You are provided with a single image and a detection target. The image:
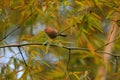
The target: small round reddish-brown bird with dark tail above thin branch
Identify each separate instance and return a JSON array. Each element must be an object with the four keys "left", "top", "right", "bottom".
[{"left": 45, "top": 27, "right": 66, "bottom": 39}]
